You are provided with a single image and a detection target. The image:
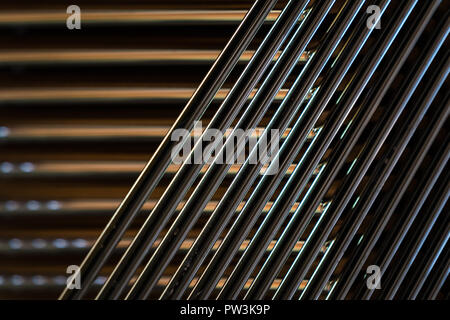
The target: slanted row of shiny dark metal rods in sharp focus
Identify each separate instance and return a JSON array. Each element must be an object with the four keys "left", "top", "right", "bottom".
[{"left": 60, "top": 0, "right": 450, "bottom": 299}]
